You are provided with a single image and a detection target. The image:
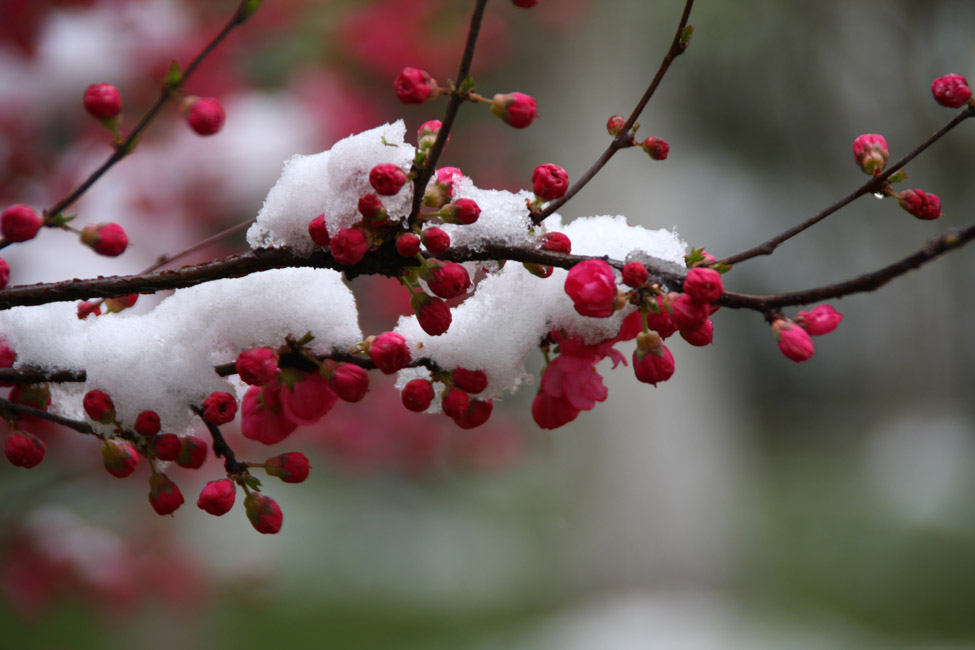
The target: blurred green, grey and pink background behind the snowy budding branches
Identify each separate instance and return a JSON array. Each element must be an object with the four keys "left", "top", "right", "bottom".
[{"left": 0, "top": 0, "right": 975, "bottom": 650}]
